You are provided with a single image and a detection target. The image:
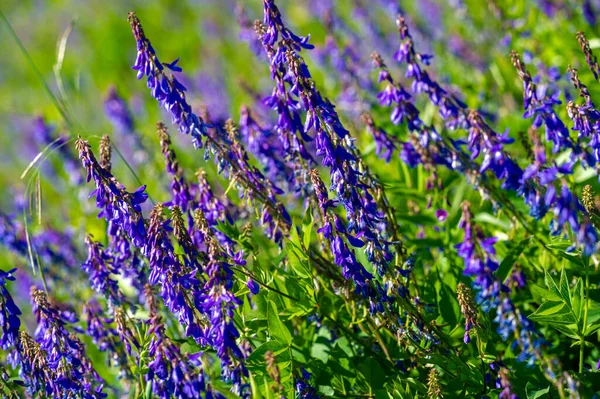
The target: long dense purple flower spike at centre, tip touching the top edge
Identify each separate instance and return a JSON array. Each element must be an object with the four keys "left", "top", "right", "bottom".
[{"left": 257, "top": 0, "right": 393, "bottom": 274}]
